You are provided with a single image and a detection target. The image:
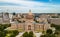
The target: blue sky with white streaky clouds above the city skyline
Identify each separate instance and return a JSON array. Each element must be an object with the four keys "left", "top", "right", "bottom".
[{"left": 0, "top": 0, "right": 60, "bottom": 13}]
